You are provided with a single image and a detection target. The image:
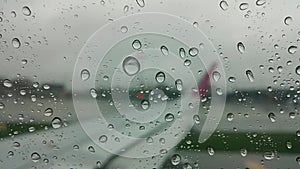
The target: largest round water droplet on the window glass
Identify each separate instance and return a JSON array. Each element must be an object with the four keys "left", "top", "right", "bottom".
[{"left": 123, "top": 56, "right": 140, "bottom": 76}]
